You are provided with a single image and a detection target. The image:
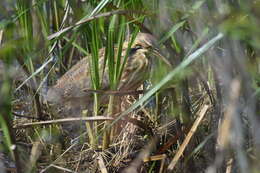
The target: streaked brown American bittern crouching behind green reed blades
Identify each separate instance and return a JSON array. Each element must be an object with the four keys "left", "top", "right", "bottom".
[{"left": 47, "top": 33, "right": 170, "bottom": 116}]
